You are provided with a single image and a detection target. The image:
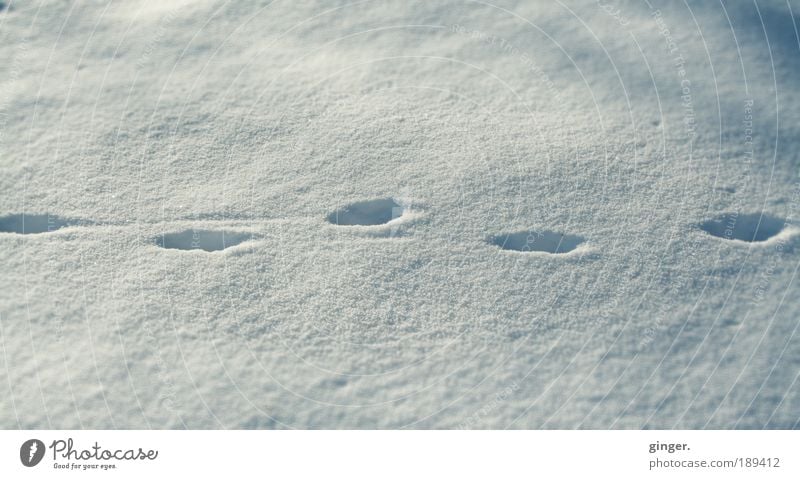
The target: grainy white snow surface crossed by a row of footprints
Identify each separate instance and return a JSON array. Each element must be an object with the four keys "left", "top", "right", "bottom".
[{"left": 0, "top": 0, "right": 800, "bottom": 428}]
